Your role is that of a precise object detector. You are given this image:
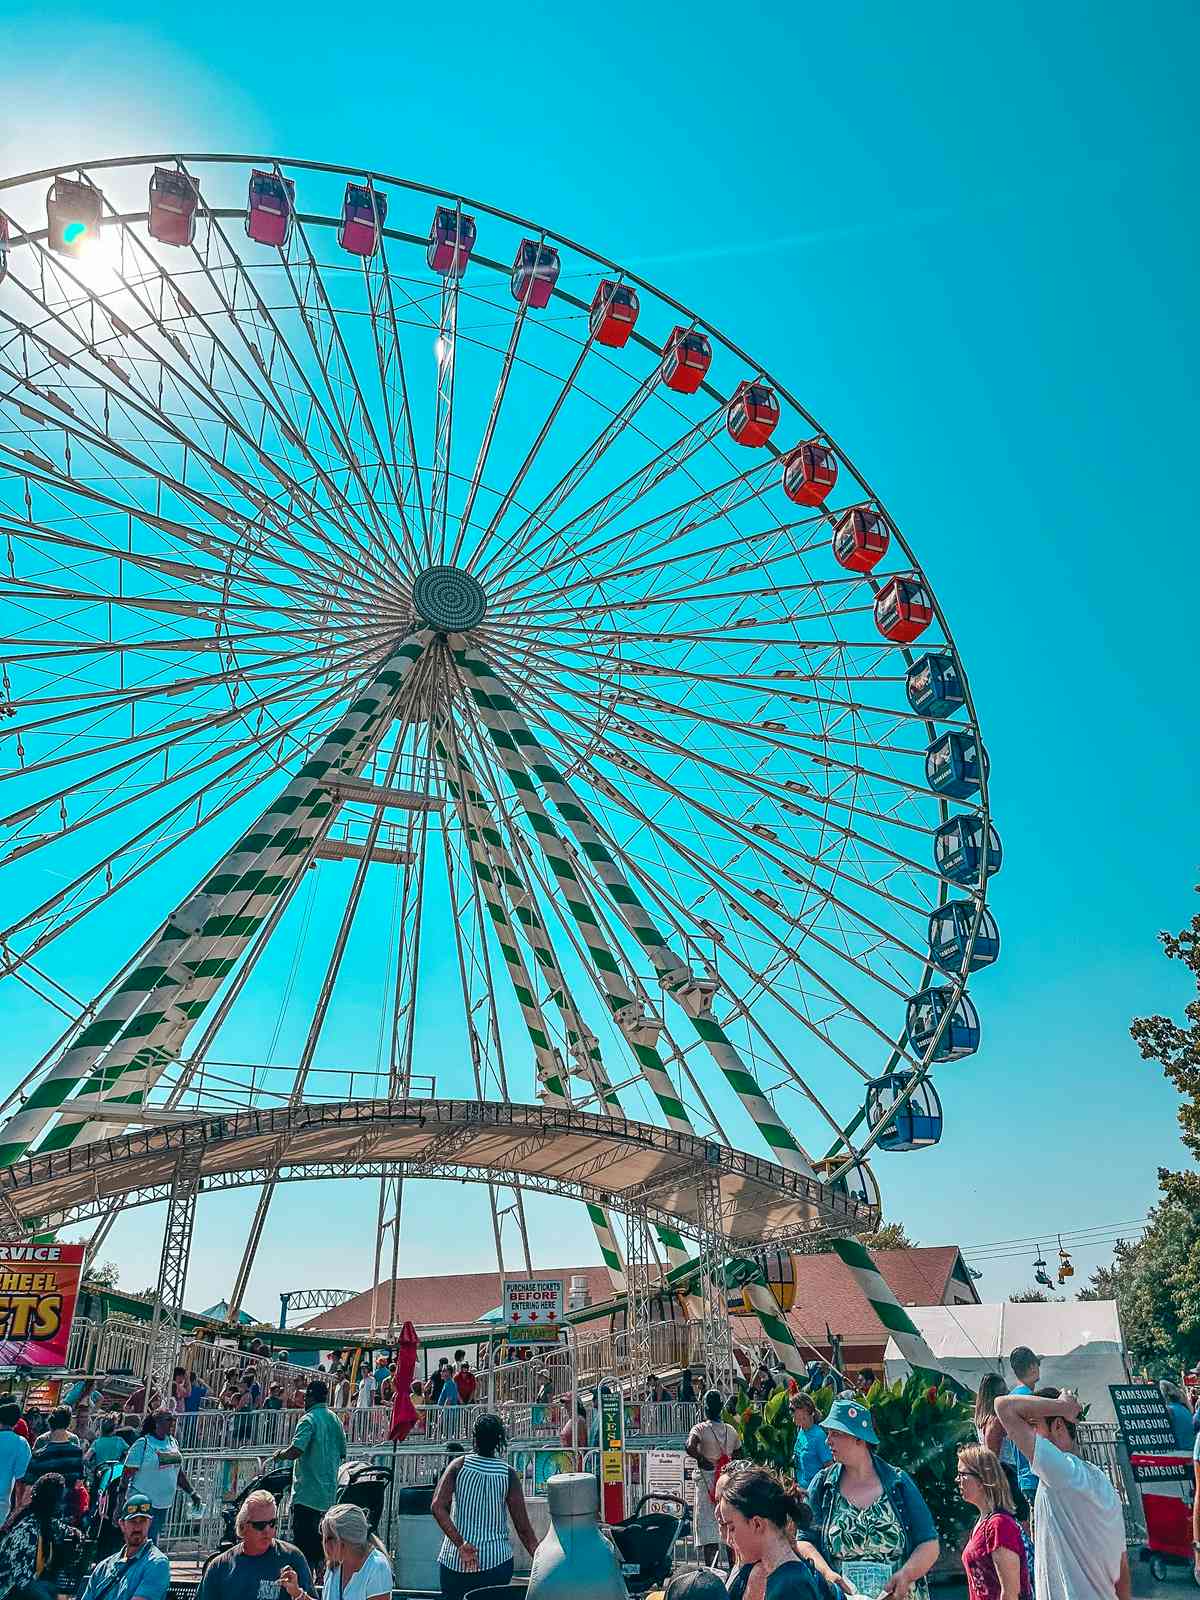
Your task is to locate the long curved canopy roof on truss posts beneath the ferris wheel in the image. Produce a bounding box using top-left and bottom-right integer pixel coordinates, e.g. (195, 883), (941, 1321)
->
(0, 1099), (877, 1250)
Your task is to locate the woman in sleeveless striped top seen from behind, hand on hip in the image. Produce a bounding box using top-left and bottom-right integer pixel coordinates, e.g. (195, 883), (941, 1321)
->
(434, 1411), (538, 1600)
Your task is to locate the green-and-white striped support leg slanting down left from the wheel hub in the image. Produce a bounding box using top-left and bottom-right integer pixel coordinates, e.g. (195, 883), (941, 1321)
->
(0, 630), (432, 1166)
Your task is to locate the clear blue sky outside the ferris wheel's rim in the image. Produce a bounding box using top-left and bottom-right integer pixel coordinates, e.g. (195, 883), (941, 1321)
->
(0, 0), (1200, 1314)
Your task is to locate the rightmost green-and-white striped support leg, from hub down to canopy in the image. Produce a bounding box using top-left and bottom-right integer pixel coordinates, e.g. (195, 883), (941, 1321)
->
(454, 650), (813, 1178)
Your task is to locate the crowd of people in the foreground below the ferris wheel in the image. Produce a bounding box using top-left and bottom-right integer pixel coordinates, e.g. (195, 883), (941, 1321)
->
(0, 1349), (1131, 1600)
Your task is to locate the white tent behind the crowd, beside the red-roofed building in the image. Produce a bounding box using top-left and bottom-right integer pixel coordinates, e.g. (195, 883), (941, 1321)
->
(885, 1301), (1130, 1422)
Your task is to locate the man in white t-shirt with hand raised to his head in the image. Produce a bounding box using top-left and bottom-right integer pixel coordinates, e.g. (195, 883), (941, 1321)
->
(995, 1389), (1131, 1600)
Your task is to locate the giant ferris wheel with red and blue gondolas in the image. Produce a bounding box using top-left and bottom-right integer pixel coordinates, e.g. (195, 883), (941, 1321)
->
(0, 155), (1000, 1304)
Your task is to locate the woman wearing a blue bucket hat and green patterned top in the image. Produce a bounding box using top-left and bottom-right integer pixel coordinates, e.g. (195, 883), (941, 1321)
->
(808, 1398), (939, 1600)
